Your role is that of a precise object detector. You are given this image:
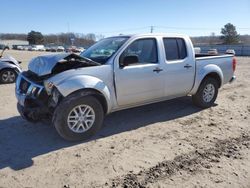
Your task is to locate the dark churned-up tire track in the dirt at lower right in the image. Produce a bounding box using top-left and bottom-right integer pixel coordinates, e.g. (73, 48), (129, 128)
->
(109, 133), (250, 188)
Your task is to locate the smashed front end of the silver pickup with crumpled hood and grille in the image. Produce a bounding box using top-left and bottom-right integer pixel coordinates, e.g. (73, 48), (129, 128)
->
(15, 54), (99, 122)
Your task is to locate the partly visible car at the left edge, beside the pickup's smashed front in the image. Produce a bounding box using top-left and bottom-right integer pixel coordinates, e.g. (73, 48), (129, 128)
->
(0, 48), (21, 84)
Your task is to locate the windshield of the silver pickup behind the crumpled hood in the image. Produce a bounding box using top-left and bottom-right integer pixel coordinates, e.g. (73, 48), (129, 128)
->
(80, 37), (128, 64)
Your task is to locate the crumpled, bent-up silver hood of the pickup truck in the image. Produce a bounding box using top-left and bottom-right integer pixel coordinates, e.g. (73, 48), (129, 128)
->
(28, 53), (89, 76)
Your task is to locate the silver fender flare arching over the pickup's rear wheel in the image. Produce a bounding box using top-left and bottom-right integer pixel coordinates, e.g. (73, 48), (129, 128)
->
(190, 64), (224, 95)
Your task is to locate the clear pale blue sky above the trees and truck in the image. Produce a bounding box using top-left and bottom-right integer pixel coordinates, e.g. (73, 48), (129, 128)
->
(0, 0), (250, 36)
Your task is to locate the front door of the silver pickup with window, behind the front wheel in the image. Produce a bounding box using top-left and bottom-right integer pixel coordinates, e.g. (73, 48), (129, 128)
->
(115, 37), (164, 106)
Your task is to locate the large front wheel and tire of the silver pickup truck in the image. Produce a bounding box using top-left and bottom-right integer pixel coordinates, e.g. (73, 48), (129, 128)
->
(52, 92), (104, 141)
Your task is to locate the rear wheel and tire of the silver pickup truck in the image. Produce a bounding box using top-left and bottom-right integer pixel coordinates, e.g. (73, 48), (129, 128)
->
(192, 78), (219, 108)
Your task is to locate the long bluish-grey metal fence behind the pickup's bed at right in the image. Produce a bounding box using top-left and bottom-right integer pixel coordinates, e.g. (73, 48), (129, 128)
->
(195, 45), (250, 56)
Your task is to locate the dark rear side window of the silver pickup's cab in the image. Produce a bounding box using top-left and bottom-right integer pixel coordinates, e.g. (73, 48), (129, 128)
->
(163, 38), (187, 61)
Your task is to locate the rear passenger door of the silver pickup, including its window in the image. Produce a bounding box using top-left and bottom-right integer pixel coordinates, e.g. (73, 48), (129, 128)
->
(163, 38), (195, 96)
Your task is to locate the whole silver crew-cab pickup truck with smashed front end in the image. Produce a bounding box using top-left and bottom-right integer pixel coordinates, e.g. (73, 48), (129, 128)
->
(16, 34), (236, 141)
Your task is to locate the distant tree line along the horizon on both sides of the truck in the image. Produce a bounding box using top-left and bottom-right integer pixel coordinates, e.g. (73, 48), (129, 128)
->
(0, 23), (250, 47)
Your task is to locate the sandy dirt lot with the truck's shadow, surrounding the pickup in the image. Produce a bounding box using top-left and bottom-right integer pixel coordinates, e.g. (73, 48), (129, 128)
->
(0, 51), (250, 188)
